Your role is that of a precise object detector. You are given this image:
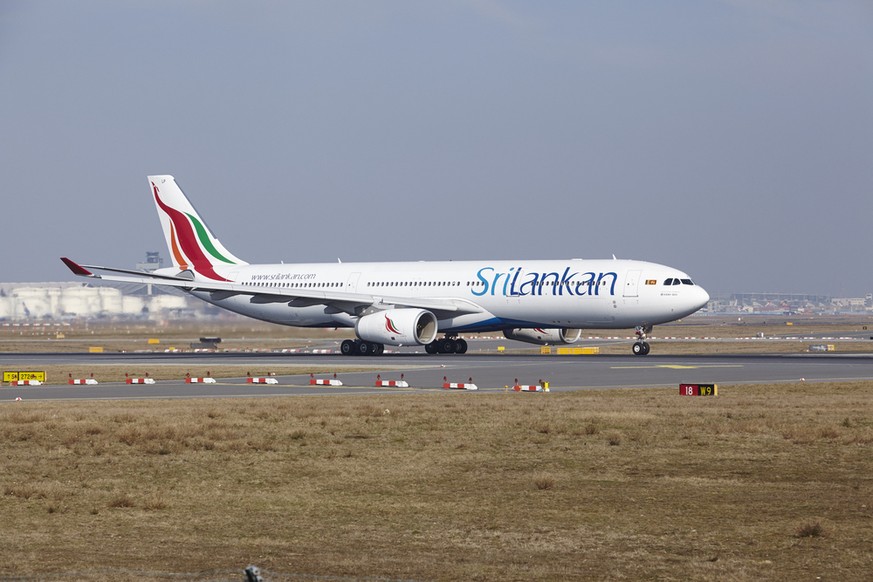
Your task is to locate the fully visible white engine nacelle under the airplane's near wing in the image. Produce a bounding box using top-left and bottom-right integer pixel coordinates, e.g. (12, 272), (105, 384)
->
(355, 309), (438, 346)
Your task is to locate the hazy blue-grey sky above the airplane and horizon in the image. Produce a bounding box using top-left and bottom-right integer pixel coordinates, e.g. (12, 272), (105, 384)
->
(0, 0), (873, 297)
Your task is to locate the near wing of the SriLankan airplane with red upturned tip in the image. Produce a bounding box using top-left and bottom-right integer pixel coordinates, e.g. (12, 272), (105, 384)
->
(61, 257), (483, 315)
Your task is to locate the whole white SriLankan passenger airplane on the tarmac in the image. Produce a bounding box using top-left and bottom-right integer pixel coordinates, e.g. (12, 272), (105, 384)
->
(61, 175), (709, 356)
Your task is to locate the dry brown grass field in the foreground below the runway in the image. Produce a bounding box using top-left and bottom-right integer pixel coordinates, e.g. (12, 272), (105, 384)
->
(0, 382), (873, 580)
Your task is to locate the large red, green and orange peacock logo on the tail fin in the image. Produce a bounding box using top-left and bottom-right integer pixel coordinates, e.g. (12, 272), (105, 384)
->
(152, 183), (236, 281)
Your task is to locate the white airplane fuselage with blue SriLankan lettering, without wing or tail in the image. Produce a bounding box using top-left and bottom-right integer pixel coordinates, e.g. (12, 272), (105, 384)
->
(181, 259), (709, 333)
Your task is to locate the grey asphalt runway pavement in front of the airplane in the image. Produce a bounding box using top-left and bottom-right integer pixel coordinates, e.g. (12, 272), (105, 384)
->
(0, 353), (873, 401)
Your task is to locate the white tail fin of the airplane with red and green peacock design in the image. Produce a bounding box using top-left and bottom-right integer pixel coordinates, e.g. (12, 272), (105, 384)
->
(149, 176), (248, 281)
